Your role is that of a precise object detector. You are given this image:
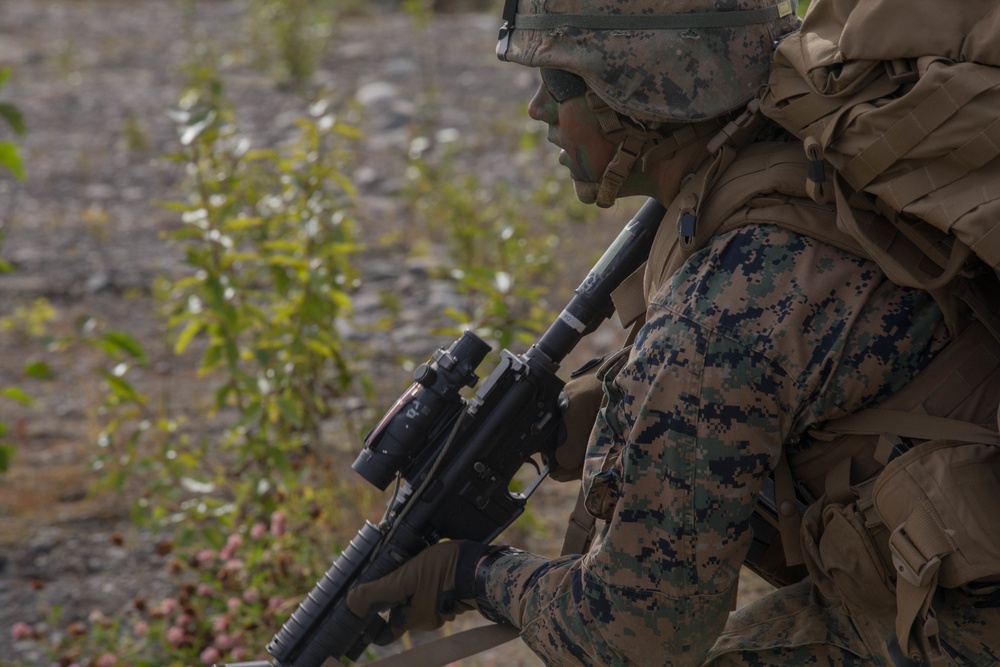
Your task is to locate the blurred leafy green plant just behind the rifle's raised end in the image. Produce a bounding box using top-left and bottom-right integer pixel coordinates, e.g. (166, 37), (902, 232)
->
(404, 128), (594, 349)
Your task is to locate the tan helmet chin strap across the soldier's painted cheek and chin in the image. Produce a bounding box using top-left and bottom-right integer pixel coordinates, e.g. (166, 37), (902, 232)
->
(574, 90), (719, 208)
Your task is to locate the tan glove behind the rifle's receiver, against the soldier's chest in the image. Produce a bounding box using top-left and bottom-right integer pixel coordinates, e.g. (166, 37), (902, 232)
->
(549, 373), (604, 482)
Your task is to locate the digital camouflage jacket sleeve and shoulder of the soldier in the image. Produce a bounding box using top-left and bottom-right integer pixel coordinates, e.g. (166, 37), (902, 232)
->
(480, 225), (948, 666)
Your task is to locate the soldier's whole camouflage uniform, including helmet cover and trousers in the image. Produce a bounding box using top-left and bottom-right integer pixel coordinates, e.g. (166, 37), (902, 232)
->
(487, 0), (1000, 667)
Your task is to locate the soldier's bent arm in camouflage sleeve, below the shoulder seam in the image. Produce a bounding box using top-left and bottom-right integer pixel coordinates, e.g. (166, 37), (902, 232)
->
(488, 311), (787, 665)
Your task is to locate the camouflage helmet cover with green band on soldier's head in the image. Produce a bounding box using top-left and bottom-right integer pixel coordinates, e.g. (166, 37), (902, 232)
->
(497, 0), (799, 121)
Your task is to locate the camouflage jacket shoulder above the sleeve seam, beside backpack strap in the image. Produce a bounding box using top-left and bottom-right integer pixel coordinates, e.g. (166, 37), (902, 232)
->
(647, 225), (886, 381)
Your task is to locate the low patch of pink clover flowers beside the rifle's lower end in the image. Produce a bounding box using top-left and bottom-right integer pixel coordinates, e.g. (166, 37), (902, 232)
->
(19, 484), (372, 667)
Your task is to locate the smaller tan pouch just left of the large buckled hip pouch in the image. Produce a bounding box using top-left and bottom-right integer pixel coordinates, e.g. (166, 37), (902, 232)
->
(802, 481), (896, 615)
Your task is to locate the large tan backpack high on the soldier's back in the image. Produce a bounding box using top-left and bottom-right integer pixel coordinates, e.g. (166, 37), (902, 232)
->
(761, 0), (1000, 335)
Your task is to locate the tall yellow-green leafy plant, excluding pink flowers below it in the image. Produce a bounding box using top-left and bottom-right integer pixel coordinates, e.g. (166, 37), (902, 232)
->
(91, 77), (366, 531)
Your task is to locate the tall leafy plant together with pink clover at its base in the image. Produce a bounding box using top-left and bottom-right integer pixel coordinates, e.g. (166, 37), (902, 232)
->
(12, 70), (376, 667)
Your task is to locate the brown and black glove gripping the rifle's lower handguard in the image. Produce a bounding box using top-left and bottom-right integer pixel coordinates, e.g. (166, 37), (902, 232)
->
(347, 540), (490, 646)
